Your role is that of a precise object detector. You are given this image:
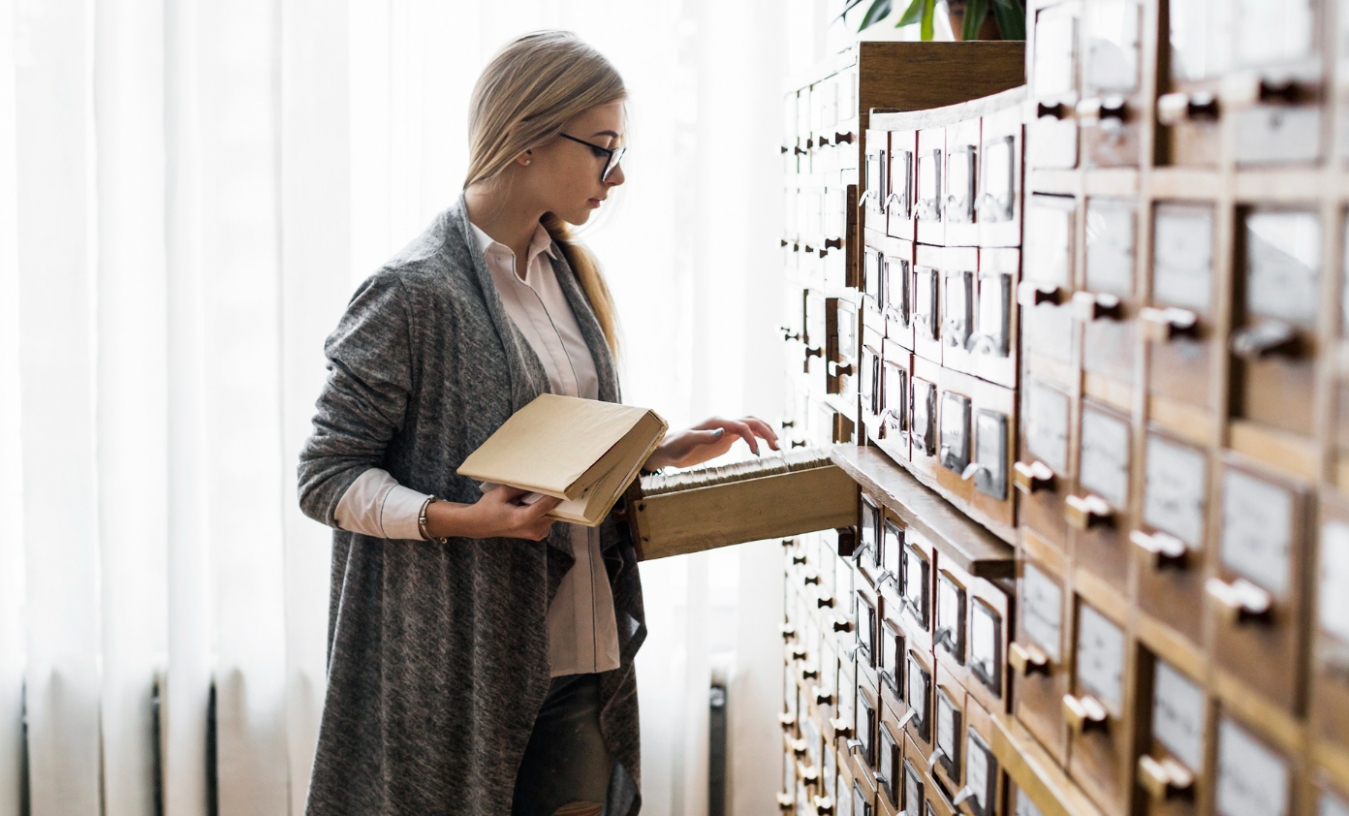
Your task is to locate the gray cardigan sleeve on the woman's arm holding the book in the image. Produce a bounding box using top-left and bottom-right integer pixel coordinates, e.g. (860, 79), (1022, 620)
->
(298, 270), (413, 527)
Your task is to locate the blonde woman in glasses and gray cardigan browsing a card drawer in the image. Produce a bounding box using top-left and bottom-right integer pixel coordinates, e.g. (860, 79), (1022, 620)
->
(299, 32), (777, 816)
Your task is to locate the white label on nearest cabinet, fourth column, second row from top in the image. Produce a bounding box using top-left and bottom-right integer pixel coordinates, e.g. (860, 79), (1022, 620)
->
(1245, 212), (1321, 325)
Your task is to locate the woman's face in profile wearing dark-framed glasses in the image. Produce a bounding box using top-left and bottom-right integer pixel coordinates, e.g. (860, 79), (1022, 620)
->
(521, 103), (623, 224)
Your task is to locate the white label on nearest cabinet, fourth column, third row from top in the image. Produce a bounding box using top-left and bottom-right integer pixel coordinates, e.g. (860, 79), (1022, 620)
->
(1221, 469), (1294, 598)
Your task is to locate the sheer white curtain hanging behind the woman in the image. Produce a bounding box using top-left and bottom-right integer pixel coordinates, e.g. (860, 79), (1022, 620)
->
(0, 0), (814, 816)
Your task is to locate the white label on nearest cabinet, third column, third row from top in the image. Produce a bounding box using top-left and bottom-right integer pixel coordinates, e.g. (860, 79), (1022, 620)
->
(1143, 436), (1209, 549)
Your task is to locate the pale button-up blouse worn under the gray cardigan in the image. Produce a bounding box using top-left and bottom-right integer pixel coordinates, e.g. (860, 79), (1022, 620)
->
(336, 218), (619, 677)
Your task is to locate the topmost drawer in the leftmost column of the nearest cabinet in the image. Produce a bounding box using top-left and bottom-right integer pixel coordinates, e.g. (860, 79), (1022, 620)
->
(1025, 1), (1082, 170)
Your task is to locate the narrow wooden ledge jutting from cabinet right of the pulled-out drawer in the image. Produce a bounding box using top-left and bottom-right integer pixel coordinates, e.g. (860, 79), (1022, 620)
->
(830, 445), (1016, 579)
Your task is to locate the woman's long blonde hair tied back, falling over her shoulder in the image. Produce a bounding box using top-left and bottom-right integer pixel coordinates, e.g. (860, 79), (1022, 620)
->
(464, 31), (627, 355)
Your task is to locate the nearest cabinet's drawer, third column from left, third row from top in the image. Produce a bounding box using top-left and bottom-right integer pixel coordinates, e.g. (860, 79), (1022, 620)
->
(1130, 430), (1210, 649)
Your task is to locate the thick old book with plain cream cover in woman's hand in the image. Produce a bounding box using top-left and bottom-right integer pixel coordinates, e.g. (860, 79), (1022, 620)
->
(459, 394), (669, 527)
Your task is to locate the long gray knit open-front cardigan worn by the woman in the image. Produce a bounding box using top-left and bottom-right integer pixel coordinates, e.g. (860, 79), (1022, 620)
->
(299, 197), (646, 816)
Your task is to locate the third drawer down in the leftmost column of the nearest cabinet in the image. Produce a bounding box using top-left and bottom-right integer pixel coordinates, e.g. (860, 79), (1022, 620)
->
(1012, 378), (1077, 550)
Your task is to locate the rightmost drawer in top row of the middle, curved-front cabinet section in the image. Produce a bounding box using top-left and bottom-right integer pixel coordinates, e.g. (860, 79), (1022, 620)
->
(978, 101), (1021, 247)
